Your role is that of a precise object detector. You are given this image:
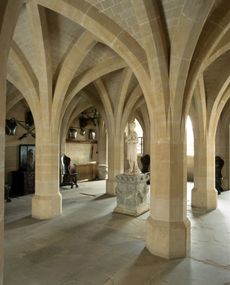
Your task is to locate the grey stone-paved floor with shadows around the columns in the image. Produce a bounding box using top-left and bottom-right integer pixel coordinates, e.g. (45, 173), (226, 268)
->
(4, 181), (230, 285)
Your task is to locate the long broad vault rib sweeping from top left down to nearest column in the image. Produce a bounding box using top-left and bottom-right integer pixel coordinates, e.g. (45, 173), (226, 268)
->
(37, 0), (150, 110)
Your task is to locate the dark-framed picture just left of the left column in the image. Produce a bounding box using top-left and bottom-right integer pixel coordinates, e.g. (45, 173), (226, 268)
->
(19, 144), (35, 171)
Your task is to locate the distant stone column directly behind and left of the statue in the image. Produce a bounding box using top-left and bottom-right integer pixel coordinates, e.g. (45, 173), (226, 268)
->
(106, 134), (124, 196)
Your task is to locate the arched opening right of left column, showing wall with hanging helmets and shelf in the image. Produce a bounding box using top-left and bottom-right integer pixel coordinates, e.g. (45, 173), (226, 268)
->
(61, 106), (101, 183)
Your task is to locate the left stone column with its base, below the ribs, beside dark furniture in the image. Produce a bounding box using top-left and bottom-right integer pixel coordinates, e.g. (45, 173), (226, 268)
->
(32, 138), (62, 219)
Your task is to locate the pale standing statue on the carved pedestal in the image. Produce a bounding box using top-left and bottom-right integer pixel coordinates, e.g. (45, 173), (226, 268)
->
(126, 121), (140, 174)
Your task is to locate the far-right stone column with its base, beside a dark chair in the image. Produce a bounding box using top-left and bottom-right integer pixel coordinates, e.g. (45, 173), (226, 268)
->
(192, 138), (217, 211)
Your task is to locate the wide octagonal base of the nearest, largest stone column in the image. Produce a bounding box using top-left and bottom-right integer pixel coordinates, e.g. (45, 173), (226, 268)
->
(146, 217), (190, 259)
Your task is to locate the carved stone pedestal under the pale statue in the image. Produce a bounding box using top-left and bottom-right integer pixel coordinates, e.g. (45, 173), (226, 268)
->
(114, 173), (149, 216)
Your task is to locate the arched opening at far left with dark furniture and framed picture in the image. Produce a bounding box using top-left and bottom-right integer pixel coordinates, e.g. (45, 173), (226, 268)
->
(5, 96), (35, 201)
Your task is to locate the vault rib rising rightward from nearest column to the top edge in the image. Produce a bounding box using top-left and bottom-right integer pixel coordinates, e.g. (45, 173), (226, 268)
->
(170, 0), (215, 123)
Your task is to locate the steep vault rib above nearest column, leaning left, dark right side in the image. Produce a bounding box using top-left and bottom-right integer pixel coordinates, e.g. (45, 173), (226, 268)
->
(132, 0), (170, 115)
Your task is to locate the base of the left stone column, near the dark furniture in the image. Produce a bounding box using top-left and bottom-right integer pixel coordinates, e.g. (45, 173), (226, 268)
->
(32, 193), (62, 220)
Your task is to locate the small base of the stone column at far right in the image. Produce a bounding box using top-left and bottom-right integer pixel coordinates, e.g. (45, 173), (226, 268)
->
(192, 188), (217, 211)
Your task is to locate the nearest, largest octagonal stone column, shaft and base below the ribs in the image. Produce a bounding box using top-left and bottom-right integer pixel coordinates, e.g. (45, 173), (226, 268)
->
(146, 130), (190, 259)
